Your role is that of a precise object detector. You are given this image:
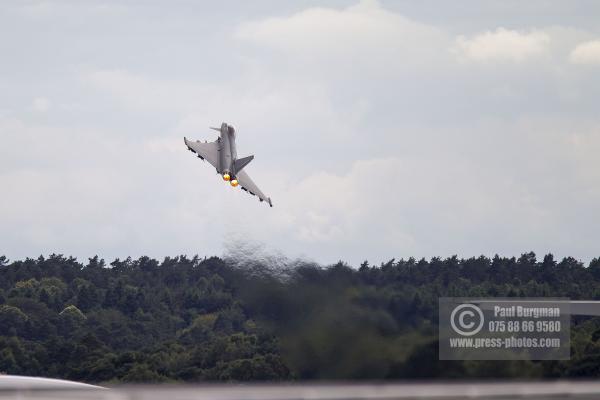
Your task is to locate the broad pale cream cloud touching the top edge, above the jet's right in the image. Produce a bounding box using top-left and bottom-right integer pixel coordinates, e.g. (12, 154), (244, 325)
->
(235, 0), (447, 73)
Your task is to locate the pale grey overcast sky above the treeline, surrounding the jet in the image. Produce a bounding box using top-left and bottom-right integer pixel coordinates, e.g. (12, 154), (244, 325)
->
(0, 0), (600, 265)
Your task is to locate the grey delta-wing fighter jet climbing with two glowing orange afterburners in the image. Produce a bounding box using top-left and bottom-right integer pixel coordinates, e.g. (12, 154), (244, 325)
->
(183, 122), (273, 207)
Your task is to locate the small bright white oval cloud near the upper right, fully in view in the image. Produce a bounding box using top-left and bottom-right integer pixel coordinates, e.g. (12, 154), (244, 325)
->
(452, 28), (550, 63)
